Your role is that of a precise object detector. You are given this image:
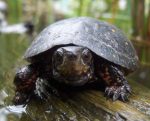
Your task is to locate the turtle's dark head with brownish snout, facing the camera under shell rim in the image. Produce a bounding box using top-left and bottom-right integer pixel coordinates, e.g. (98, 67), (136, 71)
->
(52, 46), (94, 85)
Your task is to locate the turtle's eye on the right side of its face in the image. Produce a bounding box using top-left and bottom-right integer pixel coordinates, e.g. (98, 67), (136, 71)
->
(82, 49), (92, 63)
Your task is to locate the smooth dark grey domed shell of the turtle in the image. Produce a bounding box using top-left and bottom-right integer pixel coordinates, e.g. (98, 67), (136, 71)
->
(24, 17), (138, 71)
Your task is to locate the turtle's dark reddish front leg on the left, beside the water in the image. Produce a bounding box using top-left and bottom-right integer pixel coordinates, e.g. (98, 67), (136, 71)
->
(13, 65), (38, 105)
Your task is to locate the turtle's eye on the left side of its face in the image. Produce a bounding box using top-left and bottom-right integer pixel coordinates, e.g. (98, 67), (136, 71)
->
(54, 51), (63, 65)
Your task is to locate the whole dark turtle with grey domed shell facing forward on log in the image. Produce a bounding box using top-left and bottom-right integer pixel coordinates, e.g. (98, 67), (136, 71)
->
(14, 17), (139, 104)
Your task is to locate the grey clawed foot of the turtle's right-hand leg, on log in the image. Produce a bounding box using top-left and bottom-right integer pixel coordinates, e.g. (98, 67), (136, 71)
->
(105, 85), (131, 102)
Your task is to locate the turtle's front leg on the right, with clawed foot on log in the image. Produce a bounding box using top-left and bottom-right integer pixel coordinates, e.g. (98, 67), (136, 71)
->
(100, 65), (131, 101)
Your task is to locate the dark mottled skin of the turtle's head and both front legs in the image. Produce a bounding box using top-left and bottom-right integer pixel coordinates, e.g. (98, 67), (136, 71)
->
(14, 46), (131, 105)
